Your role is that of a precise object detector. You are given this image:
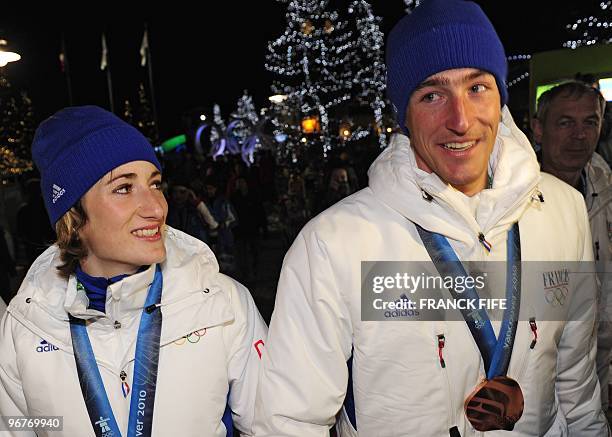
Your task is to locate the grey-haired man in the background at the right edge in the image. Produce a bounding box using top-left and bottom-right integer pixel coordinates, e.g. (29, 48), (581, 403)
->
(533, 81), (612, 411)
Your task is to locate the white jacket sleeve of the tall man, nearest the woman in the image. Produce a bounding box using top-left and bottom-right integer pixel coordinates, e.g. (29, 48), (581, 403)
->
(255, 232), (352, 437)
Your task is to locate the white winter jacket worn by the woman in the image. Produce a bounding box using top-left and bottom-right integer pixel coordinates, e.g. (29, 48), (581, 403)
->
(0, 227), (266, 437)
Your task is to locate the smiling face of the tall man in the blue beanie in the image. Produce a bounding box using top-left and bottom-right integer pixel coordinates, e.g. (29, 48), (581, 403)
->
(406, 68), (501, 196)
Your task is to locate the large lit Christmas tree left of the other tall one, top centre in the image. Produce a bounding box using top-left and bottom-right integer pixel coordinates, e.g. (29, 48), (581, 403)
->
(265, 0), (354, 156)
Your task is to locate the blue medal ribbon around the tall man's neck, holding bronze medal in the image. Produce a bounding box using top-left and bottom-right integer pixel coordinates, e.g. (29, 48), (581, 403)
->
(415, 223), (521, 379)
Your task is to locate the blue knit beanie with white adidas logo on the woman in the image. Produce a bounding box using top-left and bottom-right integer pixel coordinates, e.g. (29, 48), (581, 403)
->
(32, 106), (161, 226)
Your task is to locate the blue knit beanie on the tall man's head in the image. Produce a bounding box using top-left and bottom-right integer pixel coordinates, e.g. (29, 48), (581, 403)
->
(386, 0), (508, 133)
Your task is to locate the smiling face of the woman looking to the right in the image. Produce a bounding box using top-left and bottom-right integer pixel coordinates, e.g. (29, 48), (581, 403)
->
(79, 161), (168, 278)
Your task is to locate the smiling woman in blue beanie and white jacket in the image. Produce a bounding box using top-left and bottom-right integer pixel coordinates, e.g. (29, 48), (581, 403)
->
(0, 106), (266, 437)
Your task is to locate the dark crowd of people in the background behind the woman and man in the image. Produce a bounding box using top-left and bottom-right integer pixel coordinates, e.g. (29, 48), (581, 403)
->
(0, 141), (365, 302)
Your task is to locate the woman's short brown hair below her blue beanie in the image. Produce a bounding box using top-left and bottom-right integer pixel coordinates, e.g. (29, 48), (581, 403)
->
(55, 200), (87, 278)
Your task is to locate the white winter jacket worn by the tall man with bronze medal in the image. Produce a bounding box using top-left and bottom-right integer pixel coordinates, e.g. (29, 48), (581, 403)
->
(255, 108), (607, 437)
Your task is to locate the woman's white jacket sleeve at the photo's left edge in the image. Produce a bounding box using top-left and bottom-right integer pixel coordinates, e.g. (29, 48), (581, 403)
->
(0, 312), (36, 437)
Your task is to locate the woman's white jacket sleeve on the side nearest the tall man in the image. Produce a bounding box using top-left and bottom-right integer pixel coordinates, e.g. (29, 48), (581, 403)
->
(224, 280), (268, 436)
